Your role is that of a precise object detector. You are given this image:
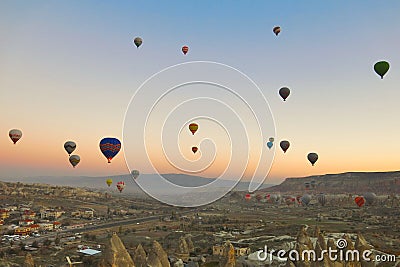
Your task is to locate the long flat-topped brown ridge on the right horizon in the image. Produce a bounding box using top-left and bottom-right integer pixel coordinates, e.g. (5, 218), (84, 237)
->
(261, 171), (400, 194)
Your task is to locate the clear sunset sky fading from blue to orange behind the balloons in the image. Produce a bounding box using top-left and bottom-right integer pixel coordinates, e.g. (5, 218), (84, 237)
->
(0, 0), (400, 183)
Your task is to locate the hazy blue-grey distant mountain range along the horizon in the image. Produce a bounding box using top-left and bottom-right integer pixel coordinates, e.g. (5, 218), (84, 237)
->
(2, 174), (273, 194)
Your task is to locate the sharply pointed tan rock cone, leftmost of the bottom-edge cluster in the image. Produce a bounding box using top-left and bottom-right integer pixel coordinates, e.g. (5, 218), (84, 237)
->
(100, 233), (135, 267)
